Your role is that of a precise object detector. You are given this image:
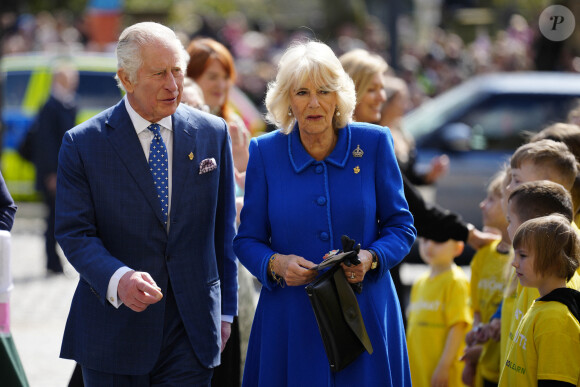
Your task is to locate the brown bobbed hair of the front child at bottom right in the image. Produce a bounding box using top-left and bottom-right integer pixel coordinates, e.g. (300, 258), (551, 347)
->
(513, 214), (580, 281)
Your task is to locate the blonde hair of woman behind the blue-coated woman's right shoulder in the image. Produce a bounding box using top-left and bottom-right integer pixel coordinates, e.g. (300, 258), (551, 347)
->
(339, 48), (389, 107)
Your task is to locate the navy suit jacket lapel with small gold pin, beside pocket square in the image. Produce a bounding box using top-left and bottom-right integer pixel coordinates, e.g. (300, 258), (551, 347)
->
(171, 108), (199, 218)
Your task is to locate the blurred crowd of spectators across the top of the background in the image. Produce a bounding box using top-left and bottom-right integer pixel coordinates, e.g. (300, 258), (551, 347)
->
(0, 11), (580, 115)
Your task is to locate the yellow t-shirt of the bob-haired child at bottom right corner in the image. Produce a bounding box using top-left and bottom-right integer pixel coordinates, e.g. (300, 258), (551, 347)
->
(499, 301), (580, 387)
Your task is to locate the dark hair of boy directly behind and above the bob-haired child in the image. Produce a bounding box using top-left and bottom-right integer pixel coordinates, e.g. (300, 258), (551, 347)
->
(508, 180), (574, 222)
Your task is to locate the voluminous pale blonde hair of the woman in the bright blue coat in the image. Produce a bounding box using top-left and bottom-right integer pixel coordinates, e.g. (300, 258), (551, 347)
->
(265, 41), (356, 134)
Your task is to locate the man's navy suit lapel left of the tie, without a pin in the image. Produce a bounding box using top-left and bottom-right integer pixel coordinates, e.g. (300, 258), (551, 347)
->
(107, 100), (168, 224)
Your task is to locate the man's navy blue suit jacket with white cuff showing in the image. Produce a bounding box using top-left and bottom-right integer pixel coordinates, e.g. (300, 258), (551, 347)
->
(56, 100), (237, 375)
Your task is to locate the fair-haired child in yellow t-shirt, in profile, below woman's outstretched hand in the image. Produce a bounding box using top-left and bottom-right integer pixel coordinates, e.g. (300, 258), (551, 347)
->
(462, 170), (512, 387)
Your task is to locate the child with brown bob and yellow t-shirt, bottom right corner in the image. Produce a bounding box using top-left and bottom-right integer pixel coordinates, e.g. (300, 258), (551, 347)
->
(499, 215), (580, 387)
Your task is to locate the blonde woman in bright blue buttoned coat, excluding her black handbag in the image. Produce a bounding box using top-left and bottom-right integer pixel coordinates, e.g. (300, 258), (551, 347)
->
(234, 42), (416, 387)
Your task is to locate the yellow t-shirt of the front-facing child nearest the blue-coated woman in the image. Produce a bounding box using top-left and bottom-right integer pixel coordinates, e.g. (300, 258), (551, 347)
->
(407, 264), (472, 387)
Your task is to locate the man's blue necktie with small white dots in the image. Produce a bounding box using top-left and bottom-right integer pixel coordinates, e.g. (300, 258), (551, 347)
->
(147, 124), (169, 225)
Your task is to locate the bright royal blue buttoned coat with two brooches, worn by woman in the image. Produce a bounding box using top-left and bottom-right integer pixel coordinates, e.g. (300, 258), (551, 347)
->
(234, 123), (416, 387)
